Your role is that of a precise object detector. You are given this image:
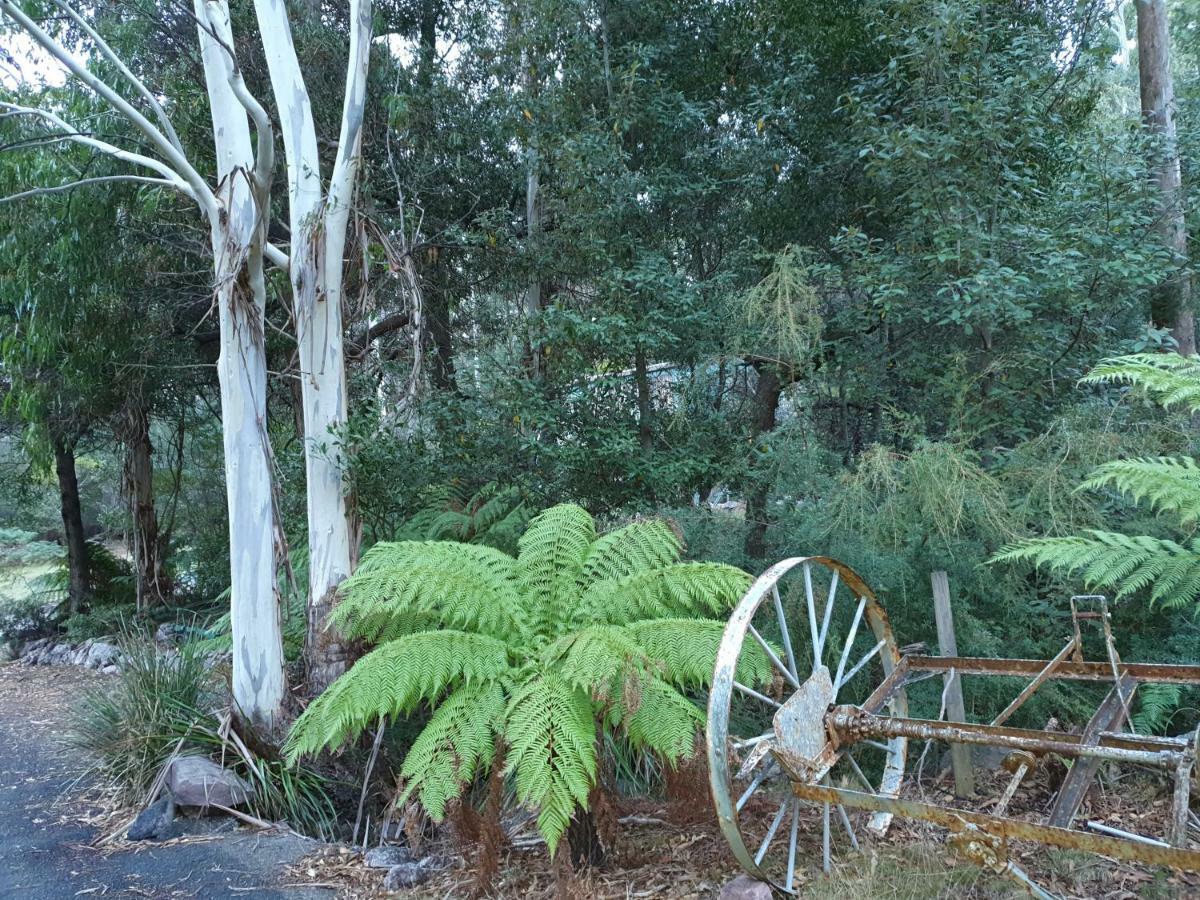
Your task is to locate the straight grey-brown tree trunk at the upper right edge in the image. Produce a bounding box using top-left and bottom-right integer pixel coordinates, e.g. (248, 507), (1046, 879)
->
(1135, 0), (1196, 355)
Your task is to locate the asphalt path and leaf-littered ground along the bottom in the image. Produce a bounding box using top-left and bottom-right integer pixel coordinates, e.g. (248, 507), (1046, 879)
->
(0, 664), (1200, 900)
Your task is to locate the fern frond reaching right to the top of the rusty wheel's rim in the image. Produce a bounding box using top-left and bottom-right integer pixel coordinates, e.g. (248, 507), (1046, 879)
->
(581, 563), (751, 624)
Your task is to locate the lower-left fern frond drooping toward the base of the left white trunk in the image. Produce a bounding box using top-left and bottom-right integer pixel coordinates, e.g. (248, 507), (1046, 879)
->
(286, 631), (510, 762)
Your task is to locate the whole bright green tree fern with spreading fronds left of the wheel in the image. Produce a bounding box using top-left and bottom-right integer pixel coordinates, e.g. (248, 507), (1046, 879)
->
(287, 504), (748, 852)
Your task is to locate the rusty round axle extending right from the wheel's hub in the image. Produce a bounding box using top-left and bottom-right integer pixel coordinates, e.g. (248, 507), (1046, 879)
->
(826, 707), (1184, 769)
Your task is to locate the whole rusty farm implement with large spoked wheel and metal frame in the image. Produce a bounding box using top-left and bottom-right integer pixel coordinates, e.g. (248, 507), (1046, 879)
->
(708, 557), (1200, 896)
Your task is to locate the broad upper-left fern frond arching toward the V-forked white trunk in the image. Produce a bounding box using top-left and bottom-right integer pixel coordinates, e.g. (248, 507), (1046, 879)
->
(331, 541), (524, 641)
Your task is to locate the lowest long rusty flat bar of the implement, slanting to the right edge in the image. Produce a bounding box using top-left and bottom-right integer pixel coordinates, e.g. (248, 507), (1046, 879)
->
(792, 782), (1200, 871)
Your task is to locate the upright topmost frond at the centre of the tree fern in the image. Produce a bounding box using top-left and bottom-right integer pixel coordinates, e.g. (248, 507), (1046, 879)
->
(517, 503), (596, 635)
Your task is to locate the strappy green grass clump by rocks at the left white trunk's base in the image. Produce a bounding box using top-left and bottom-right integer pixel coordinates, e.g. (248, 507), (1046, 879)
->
(68, 634), (337, 839)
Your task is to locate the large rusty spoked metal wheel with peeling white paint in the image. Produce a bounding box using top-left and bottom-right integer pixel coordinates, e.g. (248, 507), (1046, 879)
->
(708, 557), (907, 893)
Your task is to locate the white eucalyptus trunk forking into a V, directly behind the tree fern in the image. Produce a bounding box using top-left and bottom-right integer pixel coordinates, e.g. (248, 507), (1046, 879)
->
(254, 0), (371, 692)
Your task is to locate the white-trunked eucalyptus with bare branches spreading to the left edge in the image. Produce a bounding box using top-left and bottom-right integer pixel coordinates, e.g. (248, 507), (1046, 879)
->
(0, 0), (287, 730)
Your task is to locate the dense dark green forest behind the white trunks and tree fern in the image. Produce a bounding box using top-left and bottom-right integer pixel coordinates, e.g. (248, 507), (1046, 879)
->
(0, 0), (1200, 873)
